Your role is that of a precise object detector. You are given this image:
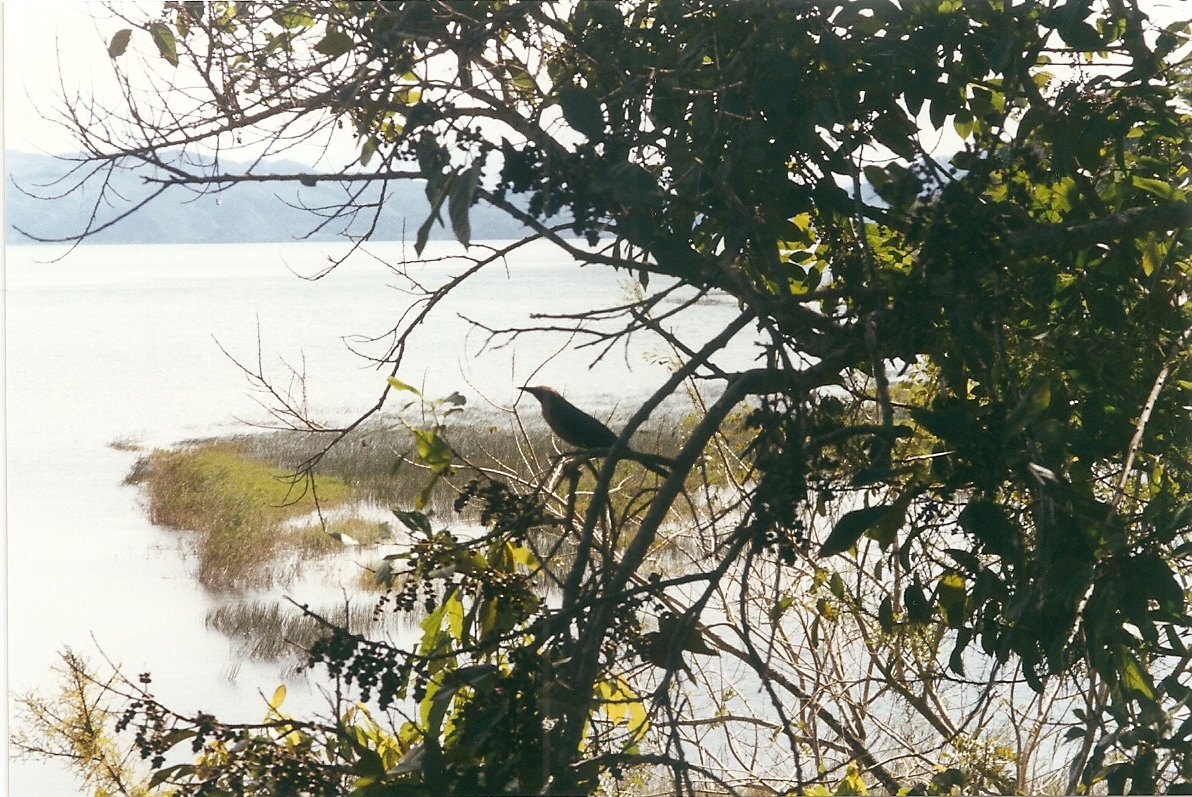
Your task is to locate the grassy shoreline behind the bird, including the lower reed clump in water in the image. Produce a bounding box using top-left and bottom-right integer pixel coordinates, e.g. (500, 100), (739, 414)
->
(123, 412), (734, 677)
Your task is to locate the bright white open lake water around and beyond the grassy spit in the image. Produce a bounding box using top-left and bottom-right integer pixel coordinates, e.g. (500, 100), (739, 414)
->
(6, 235), (751, 796)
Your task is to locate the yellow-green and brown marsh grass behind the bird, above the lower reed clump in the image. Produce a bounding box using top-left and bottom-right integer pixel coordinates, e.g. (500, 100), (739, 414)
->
(128, 400), (743, 591)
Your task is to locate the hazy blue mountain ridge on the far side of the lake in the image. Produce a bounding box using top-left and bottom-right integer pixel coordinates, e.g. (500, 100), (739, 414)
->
(5, 150), (536, 244)
